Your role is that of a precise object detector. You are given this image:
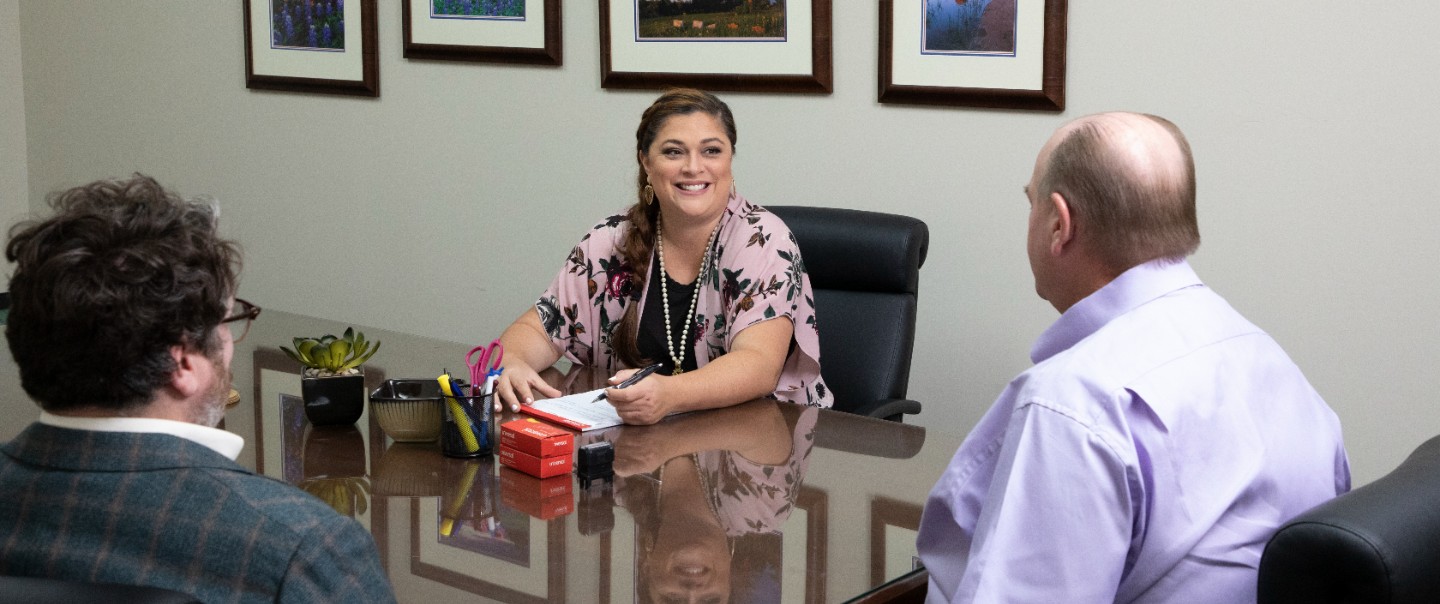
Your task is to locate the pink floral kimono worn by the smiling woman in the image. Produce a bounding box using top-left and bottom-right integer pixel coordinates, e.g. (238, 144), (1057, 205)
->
(536, 195), (832, 407)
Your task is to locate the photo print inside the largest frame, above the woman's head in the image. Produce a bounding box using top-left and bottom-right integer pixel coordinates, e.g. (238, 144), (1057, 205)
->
(635, 0), (786, 40)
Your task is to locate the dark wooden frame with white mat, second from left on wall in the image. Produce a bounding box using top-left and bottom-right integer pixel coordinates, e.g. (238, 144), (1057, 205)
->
(400, 0), (563, 65)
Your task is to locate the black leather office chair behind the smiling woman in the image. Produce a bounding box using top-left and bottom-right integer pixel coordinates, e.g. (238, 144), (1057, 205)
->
(766, 206), (930, 421)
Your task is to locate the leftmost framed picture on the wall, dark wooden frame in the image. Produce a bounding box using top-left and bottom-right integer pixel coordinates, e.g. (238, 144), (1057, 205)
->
(242, 0), (380, 97)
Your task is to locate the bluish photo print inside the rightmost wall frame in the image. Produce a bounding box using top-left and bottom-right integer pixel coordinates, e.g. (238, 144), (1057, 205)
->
(922, 0), (1017, 55)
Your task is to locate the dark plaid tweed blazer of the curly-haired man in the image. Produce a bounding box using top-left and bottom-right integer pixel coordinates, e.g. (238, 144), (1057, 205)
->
(0, 424), (395, 603)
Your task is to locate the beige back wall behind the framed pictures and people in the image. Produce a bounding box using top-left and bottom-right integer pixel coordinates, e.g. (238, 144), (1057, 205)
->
(8, 0), (1440, 481)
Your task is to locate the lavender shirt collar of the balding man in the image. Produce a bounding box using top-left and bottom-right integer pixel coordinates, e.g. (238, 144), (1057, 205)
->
(1030, 258), (1204, 363)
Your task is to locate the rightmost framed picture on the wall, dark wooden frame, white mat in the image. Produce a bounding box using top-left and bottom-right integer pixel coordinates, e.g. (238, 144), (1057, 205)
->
(880, 0), (1067, 111)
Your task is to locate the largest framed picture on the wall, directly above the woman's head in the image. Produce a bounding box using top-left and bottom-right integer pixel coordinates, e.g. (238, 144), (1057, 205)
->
(600, 0), (834, 94)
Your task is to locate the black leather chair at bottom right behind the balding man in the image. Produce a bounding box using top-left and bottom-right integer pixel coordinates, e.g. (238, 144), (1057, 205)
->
(1257, 437), (1440, 604)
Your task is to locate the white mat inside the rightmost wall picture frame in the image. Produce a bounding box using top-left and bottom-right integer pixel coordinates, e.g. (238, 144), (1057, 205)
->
(890, 0), (1045, 91)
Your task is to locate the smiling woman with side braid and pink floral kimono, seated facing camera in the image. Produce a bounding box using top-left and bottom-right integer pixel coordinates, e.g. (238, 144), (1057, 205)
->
(497, 88), (831, 424)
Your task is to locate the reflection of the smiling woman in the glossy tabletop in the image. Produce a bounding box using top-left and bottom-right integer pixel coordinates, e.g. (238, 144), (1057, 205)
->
(604, 401), (818, 603)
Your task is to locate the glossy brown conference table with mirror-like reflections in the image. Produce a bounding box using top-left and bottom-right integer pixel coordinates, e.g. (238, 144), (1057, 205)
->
(213, 310), (962, 603)
